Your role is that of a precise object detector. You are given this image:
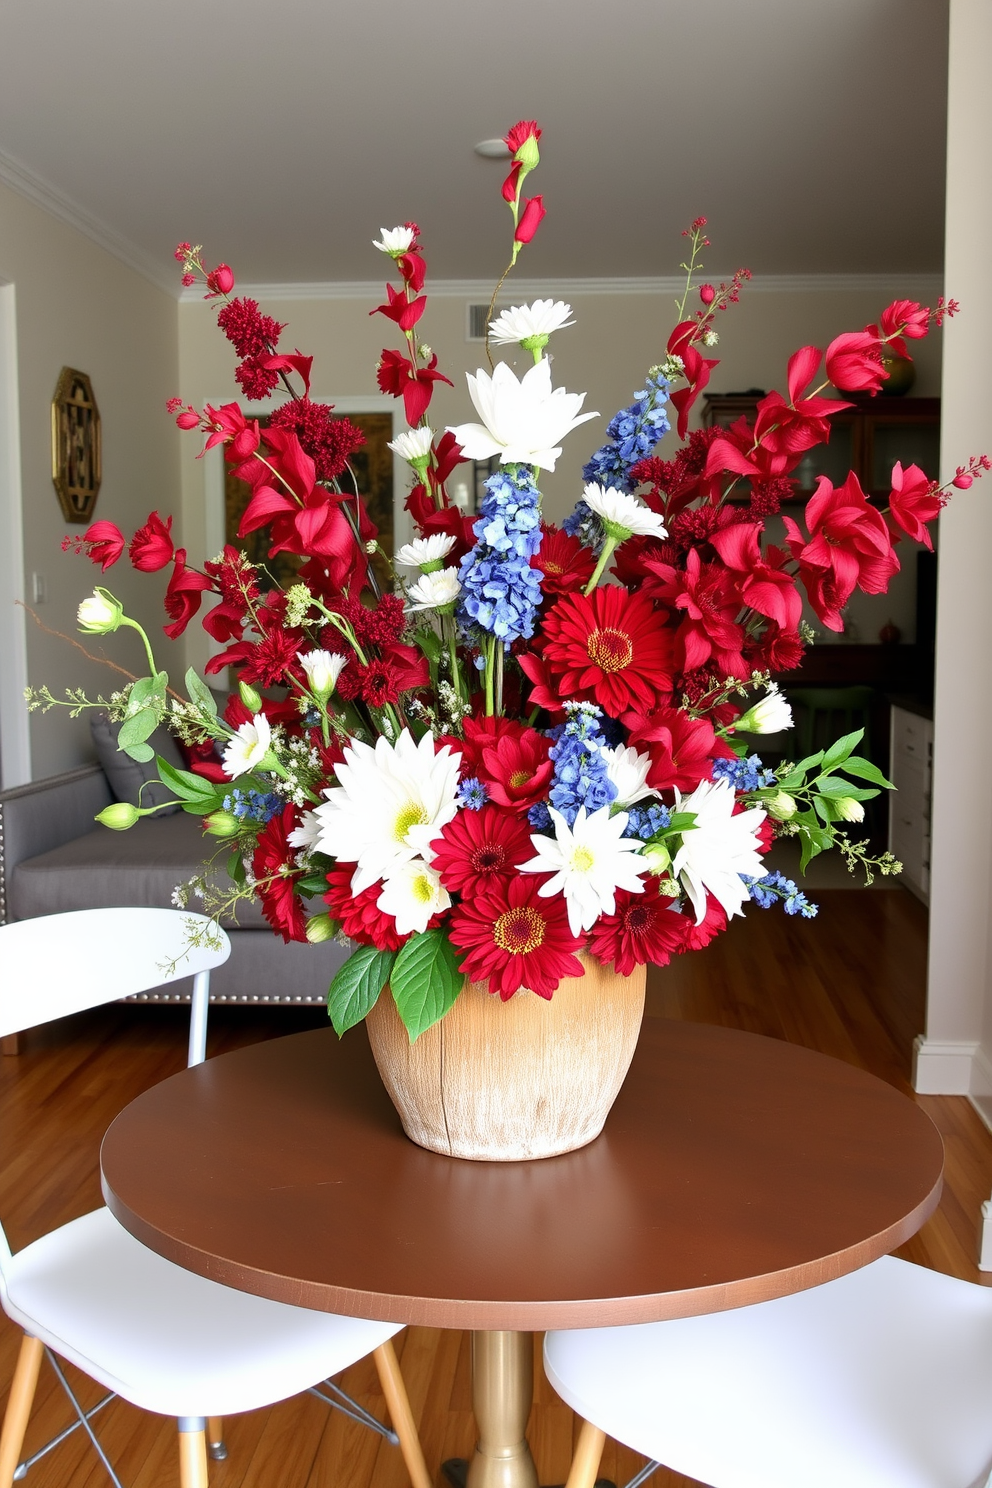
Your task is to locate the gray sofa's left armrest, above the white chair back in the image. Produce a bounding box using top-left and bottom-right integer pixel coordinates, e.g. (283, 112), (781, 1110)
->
(0, 765), (113, 924)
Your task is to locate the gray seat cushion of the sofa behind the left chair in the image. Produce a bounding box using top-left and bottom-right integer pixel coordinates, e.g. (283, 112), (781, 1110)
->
(7, 811), (268, 929)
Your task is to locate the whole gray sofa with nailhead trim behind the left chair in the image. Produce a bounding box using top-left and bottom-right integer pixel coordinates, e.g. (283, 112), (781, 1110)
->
(0, 765), (348, 1004)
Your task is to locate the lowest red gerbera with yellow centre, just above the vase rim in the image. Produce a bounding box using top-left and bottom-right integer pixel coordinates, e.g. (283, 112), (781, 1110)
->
(448, 873), (584, 1003)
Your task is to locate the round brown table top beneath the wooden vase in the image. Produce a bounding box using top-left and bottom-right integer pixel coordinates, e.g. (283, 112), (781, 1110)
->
(101, 1018), (943, 1330)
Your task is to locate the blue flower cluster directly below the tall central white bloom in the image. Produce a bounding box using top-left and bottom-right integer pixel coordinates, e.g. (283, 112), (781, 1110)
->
(457, 466), (544, 650)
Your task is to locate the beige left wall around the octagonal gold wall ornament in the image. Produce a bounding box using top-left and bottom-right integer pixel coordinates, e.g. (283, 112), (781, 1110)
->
(0, 186), (180, 778)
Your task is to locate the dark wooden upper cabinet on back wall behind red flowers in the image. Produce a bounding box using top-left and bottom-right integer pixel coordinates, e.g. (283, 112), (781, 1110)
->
(703, 393), (940, 500)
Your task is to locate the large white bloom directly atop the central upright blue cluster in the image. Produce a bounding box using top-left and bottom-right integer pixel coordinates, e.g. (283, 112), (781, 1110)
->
(448, 357), (599, 470)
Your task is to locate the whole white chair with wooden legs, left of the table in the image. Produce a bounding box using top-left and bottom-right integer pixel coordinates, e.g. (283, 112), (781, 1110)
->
(0, 909), (431, 1488)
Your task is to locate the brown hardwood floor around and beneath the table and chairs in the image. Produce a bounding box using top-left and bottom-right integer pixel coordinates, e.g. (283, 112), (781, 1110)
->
(0, 888), (992, 1488)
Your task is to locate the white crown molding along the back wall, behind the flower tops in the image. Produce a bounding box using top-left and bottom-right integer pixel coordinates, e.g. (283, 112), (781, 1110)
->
(180, 274), (943, 305)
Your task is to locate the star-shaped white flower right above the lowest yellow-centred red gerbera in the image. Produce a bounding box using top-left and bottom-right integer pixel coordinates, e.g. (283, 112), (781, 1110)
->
(521, 806), (648, 934)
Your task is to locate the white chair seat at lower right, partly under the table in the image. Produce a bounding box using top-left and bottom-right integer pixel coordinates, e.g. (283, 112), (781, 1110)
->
(544, 1256), (992, 1488)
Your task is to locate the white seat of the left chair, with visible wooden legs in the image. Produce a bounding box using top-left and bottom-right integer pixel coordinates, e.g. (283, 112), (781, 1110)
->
(4, 1208), (400, 1417)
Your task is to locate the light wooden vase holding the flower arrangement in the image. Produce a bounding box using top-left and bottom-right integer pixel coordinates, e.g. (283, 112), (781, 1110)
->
(366, 955), (645, 1162)
